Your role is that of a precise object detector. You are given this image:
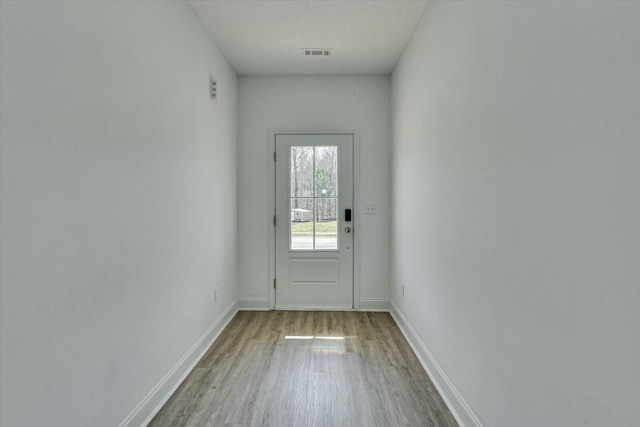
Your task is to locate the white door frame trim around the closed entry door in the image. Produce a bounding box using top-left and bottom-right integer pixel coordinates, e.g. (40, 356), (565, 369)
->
(267, 129), (362, 311)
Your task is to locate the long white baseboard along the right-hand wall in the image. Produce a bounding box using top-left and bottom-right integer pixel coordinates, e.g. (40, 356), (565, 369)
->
(391, 301), (482, 427)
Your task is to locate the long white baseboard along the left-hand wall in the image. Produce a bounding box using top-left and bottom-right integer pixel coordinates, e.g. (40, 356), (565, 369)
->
(119, 300), (238, 427)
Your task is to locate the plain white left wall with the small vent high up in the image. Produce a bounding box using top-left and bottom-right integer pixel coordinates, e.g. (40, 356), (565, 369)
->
(0, 1), (237, 427)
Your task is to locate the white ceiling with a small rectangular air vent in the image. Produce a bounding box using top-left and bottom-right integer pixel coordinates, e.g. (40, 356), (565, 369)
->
(189, 0), (428, 75)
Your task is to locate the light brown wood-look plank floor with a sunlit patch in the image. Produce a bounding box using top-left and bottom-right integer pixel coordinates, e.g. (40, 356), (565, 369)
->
(150, 311), (457, 427)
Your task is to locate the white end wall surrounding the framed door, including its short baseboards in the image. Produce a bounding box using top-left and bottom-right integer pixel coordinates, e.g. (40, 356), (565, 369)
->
(238, 76), (390, 308)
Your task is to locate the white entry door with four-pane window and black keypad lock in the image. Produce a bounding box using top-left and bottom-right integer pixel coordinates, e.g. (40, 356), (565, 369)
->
(275, 134), (354, 310)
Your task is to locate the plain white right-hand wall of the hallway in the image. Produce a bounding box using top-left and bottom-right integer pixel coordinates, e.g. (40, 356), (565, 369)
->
(392, 1), (640, 426)
